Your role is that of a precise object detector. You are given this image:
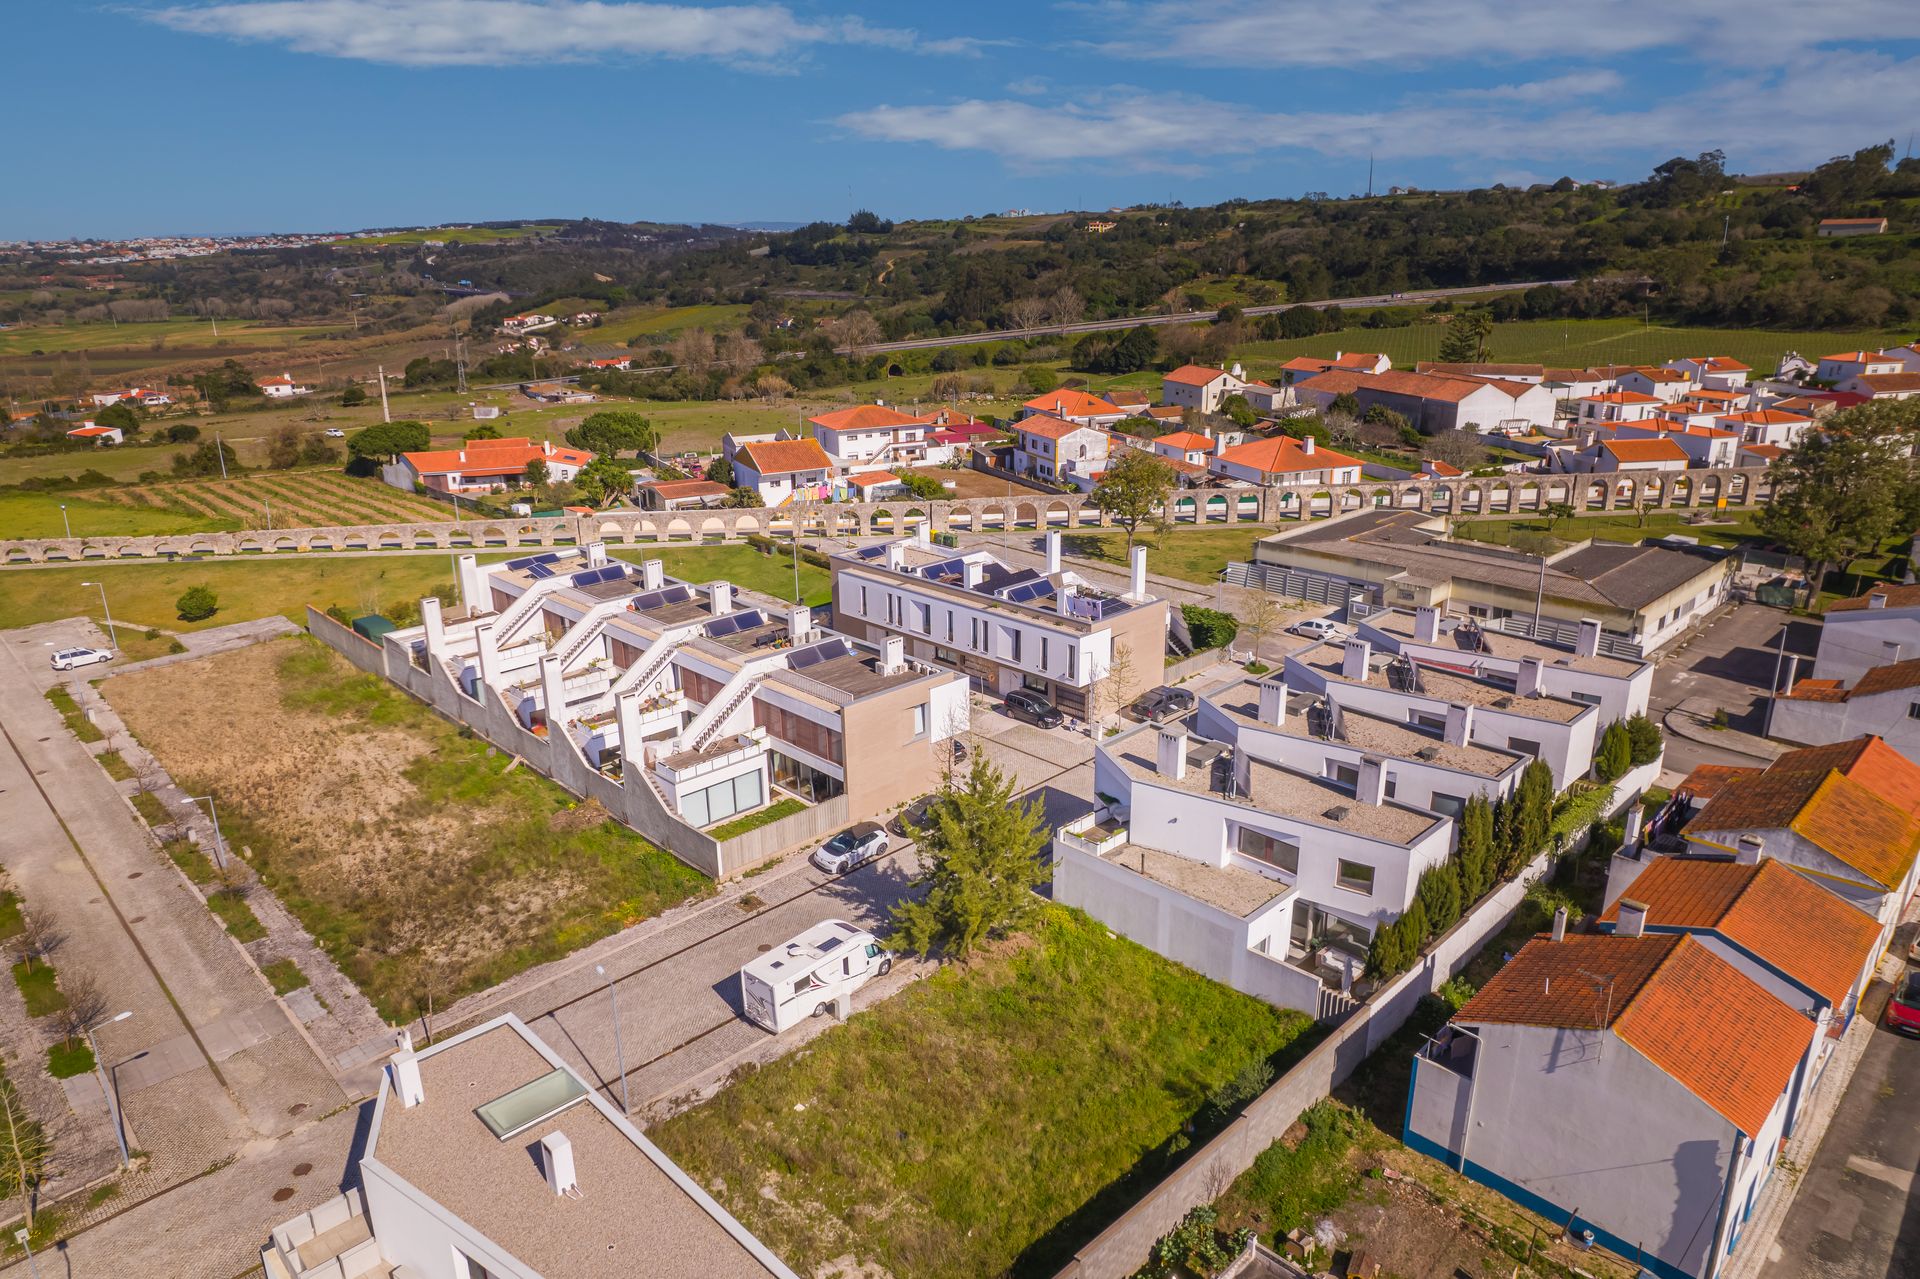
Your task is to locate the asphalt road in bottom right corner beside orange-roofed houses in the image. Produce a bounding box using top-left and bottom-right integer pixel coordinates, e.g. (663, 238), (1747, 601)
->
(1761, 967), (1920, 1279)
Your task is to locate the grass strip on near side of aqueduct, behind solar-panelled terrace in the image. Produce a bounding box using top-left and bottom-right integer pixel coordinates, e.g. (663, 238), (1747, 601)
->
(0, 545), (829, 632)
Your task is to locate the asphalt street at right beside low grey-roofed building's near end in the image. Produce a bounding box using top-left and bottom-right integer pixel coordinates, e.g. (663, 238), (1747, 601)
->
(1647, 603), (1820, 774)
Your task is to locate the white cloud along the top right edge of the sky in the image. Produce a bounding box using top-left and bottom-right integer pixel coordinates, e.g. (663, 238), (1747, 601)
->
(1098, 0), (1920, 67)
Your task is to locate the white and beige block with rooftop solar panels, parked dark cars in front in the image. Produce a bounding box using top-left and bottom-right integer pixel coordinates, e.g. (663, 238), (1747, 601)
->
(831, 530), (1167, 720)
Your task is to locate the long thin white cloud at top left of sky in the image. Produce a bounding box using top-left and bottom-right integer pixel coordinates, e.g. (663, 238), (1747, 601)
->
(144, 0), (977, 67)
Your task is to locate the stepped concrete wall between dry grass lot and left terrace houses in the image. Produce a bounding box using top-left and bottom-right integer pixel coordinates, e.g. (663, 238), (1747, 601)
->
(307, 607), (847, 880)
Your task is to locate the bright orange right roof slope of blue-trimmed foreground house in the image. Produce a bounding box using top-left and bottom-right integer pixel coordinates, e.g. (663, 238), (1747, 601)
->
(1615, 933), (1814, 1137)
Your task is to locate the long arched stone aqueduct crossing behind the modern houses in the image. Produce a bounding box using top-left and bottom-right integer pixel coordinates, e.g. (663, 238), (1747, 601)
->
(0, 467), (1768, 565)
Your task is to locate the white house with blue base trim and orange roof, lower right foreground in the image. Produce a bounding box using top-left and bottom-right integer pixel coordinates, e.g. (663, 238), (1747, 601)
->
(1405, 916), (1816, 1279)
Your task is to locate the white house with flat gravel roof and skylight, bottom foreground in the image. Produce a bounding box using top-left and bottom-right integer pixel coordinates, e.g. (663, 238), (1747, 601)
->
(261, 1014), (797, 1279)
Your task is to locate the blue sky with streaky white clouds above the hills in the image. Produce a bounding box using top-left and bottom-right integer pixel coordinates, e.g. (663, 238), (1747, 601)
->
(11, 0), (1920, 240)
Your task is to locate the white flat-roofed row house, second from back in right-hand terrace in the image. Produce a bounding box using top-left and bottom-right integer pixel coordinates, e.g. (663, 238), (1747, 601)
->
(1286, 636), (1605, 791)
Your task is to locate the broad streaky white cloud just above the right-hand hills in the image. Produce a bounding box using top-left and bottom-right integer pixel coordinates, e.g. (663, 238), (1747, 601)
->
(835, 50), (1920, 177)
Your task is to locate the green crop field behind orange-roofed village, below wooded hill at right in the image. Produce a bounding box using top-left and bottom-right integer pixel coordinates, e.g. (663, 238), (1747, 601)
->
(1235, 319), (1912, 376)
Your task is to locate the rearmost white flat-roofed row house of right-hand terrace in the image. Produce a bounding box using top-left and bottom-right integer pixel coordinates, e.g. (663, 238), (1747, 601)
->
(1357, 605), (1653, 724)
